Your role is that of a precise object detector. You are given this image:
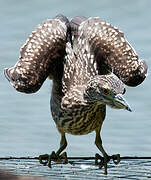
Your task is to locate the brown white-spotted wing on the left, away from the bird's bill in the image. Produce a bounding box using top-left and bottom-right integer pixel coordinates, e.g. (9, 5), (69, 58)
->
(4, 15), (69, 93)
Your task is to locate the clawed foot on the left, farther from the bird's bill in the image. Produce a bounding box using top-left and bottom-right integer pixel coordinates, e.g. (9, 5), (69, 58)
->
(39, 151), (68, 168)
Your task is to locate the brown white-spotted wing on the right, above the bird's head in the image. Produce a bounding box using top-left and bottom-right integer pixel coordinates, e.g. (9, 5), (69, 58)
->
(76, 18), (147, 86)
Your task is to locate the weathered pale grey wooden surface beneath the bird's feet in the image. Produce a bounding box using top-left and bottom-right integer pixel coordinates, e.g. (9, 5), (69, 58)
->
(0, 159), (151, 180)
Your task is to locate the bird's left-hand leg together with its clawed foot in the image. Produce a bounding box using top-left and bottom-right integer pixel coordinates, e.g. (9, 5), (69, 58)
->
(39, 130), (68, 168)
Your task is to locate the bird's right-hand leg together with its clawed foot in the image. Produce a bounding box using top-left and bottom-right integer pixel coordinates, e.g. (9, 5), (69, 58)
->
(95, 127), (120, 175)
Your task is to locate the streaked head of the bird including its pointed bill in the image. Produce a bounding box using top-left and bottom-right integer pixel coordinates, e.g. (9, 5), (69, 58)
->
(84, 73), (131, 111)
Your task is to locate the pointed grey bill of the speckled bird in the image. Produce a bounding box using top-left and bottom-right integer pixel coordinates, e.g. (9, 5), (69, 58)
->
(113, 94), (132, 112)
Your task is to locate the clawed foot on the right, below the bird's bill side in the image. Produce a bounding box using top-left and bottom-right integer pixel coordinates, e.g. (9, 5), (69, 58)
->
(95, 154), (120, 175)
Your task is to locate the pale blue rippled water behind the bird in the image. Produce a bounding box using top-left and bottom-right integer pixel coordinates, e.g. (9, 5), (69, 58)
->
(0, 0), (151, 157)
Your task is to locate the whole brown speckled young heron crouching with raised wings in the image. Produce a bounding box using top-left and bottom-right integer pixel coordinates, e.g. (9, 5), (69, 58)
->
(4, 15), (147, 174)
